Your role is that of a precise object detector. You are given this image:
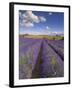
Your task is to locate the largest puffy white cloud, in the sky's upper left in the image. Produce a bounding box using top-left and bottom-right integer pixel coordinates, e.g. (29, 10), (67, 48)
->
(19, 10), (46, 27)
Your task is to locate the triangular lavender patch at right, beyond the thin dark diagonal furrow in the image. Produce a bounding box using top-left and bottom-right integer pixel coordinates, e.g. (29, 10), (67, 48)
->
(45, 40), (64, 61)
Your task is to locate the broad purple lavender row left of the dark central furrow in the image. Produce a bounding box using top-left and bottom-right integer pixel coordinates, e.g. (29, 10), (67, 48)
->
(19, 39), (42, 79)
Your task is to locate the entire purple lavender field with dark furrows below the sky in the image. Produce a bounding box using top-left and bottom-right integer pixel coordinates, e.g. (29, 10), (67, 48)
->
(19, 36), (64, 79)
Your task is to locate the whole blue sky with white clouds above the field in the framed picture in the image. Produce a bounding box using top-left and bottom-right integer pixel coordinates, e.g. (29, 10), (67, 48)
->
(19, 10), (64, 35)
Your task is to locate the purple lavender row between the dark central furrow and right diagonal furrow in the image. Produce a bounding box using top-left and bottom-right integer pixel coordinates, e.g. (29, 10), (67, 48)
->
(41, 40), (64, 78)
